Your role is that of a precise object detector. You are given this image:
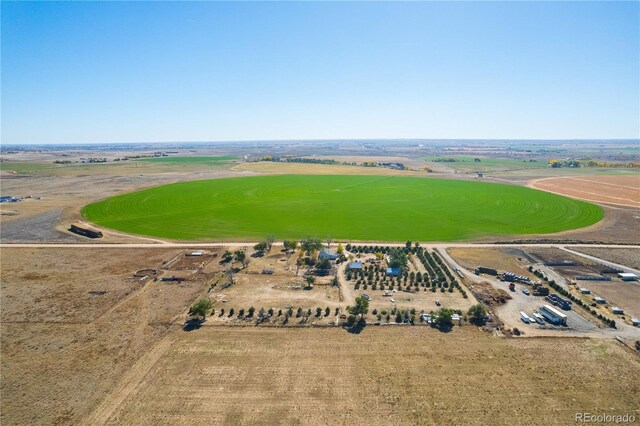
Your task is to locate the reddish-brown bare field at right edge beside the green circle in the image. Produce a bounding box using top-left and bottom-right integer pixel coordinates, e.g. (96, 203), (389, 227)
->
(529, 174), (640, 207)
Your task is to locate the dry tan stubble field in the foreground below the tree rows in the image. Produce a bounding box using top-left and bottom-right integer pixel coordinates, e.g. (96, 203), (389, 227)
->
(109, 327), (640, 425)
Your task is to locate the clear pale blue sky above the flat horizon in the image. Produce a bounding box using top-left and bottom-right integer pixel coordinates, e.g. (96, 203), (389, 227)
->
(1, 1), (640, 144)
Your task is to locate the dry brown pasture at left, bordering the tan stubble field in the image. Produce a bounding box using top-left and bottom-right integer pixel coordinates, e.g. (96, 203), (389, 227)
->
(0, 248), (212, 424)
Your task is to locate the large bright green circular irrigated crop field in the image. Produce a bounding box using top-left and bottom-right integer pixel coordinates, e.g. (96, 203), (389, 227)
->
(82, 175), (604, 241)
